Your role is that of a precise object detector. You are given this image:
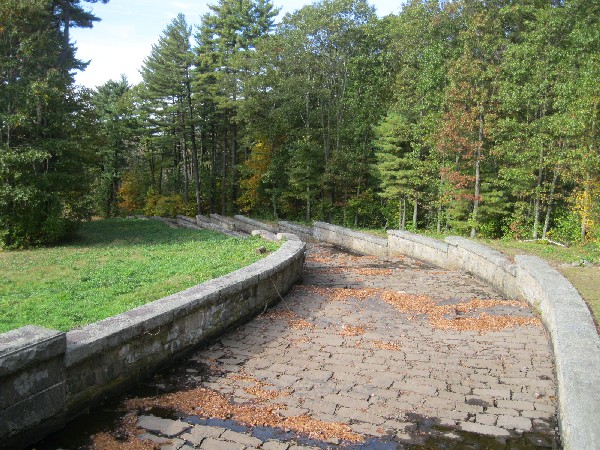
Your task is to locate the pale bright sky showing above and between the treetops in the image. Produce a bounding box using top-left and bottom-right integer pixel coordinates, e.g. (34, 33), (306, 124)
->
(71, 0), (402, 88)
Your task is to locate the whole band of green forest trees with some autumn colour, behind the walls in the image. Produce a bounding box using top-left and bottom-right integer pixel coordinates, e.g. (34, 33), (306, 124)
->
(0, 0), (600, 247)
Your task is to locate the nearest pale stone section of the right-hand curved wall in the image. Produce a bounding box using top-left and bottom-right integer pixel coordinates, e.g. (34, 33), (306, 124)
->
(515, 255), (600, 449)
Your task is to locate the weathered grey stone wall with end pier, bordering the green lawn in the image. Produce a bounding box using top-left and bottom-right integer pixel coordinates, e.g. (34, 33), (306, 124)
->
(0, 240), (305, 448)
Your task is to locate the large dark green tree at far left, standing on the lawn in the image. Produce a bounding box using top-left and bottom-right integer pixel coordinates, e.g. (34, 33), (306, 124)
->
(0, 0), (108, 247)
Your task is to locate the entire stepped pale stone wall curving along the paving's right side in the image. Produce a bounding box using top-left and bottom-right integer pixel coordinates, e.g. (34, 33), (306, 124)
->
(314, 222), (600, 449)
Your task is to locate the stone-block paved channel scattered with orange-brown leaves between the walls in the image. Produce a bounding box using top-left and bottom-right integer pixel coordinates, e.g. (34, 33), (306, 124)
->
(35, 245), (558, 450)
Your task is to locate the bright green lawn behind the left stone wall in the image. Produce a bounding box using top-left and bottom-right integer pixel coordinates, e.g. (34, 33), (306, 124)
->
(0, 219), (278, 332)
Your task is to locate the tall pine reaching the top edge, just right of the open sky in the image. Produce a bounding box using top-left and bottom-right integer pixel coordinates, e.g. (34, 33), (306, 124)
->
(196, 0), (278, 213)
